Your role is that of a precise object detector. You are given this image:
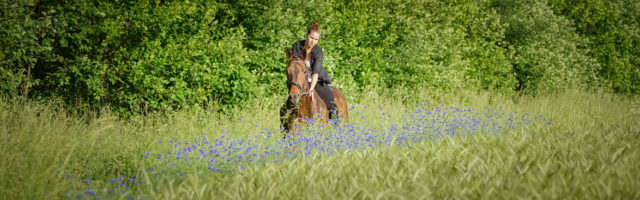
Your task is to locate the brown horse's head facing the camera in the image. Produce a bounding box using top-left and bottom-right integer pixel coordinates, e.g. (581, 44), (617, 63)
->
(287, 50), (309, 103)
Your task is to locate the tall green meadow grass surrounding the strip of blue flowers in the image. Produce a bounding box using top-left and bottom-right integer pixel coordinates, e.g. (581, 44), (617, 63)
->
(0, 91), (640, 199)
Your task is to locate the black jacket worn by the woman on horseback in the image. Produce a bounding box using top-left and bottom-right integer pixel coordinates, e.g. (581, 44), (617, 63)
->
(291, 40), (331, 84)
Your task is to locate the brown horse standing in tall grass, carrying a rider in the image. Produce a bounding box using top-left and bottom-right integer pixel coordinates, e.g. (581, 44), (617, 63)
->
(280, 50), (349, 137)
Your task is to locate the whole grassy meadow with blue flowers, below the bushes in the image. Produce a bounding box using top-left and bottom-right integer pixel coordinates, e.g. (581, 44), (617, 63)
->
(0, 90), (640, 199)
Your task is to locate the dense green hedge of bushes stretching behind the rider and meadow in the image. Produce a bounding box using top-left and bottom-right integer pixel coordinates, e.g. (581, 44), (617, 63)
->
(0, 0), (640, 114)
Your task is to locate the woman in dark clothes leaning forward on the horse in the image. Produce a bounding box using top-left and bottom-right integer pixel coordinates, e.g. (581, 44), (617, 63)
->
(291, 22), (337, 119)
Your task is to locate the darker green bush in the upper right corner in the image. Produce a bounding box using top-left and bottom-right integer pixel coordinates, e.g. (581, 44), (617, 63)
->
(549, 0), (640, 94)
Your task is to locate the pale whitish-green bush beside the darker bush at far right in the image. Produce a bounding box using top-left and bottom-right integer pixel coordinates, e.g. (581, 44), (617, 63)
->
(493, 0), (597, 93)
